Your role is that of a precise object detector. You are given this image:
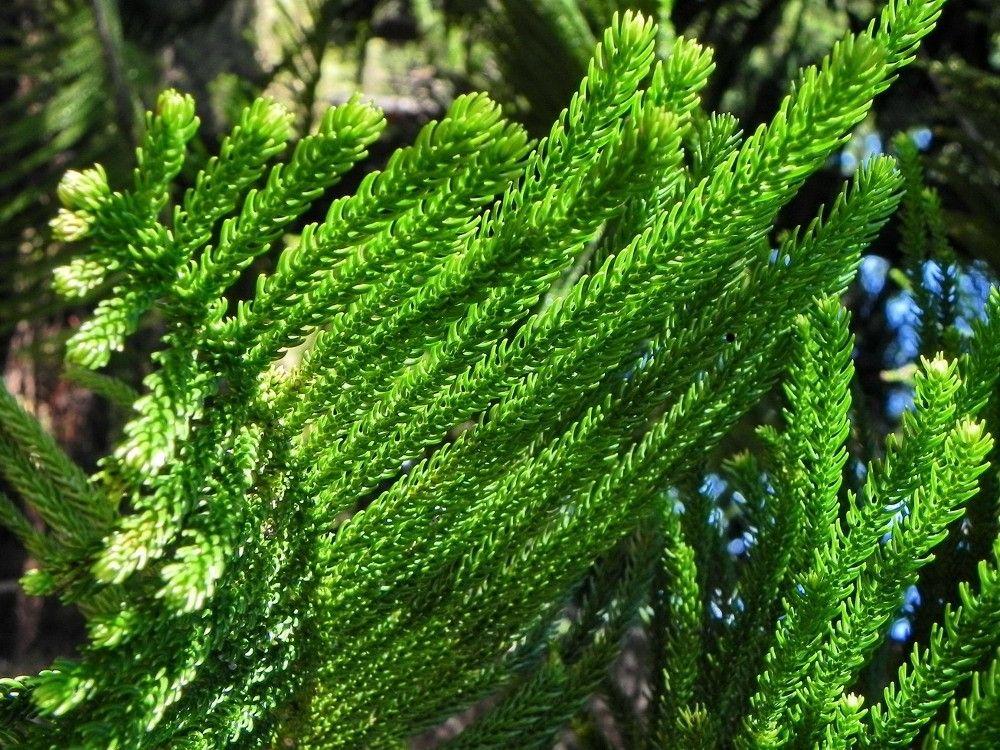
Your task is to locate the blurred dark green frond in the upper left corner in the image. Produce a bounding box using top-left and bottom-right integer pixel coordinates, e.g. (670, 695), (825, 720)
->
(0, 0), (144, 330)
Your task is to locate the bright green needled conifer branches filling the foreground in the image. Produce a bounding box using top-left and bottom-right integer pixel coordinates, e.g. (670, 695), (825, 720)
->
(0, 0), (1000, 748)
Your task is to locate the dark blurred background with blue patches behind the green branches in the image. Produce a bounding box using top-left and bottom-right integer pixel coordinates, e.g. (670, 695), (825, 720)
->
(0, 0), (1000, 748)
